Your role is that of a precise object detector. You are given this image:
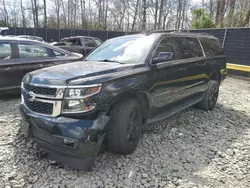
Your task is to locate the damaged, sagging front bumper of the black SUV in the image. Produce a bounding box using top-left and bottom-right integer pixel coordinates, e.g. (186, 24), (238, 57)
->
(20, 105), (109, 170)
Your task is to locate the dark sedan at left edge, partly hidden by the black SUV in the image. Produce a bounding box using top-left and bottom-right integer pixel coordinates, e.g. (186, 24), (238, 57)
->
(0, 37), (83, 94)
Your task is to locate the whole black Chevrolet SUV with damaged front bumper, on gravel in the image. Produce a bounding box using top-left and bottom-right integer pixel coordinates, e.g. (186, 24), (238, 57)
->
(20, 32), (226, 170)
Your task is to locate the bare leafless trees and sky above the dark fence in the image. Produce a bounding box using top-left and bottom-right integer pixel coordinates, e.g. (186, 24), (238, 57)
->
(0, 0), (250, 31)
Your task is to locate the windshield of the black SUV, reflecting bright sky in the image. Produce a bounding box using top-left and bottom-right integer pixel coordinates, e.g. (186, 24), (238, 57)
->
(85, 35), (155, 64)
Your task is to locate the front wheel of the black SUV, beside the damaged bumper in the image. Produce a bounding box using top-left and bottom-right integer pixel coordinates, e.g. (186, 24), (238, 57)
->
(107, 99), (142, 155)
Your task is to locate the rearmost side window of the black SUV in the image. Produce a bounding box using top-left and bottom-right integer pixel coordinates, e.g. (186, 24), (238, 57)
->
(200, 38), (222, 56)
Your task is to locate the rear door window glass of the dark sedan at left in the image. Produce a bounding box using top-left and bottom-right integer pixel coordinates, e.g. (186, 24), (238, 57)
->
(18, 44), (49, 58)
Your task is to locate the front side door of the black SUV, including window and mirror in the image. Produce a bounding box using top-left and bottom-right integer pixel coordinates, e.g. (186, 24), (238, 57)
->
(149, 37), (192, 117)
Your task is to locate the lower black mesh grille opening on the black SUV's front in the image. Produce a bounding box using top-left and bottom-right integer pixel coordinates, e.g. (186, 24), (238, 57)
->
(22, 92), (53, 115)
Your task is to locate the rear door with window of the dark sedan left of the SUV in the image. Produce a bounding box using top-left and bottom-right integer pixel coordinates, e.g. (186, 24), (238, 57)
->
(18, 42), (54, 76)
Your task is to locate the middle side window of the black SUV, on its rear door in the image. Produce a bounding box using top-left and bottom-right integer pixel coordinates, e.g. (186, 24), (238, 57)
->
(180, 37), (203, 59)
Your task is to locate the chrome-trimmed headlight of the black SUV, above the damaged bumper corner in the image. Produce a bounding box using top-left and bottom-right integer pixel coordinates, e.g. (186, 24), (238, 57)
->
(62, 86), (101, 113)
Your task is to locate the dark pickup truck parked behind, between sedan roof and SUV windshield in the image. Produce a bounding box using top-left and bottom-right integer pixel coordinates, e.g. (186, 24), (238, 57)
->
(52, 36), (102, 56)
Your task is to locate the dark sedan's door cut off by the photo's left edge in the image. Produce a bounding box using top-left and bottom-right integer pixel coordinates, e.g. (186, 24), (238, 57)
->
(0, 41), (22, 90)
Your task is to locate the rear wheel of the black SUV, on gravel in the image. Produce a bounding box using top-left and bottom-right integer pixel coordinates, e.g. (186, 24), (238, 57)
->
(196, 80), (219, 111)
